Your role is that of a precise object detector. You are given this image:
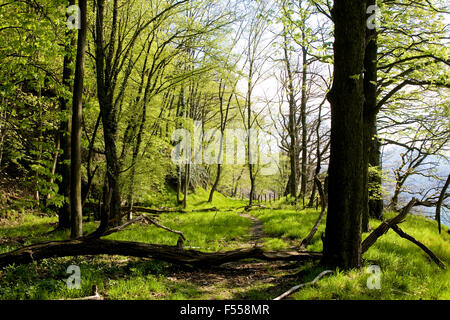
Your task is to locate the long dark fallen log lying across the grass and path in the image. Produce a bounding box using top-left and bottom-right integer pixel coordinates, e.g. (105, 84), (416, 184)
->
(0, 238), (322, 267)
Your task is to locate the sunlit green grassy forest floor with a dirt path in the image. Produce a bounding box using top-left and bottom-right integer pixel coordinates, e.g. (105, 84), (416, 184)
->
(0, 188), (450, 300)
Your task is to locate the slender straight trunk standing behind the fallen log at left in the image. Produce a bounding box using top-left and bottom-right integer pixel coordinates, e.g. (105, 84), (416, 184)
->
(70, 0), (87, 239)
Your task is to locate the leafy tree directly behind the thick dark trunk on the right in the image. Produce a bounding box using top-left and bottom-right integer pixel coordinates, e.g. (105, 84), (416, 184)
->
(363, 0), (448, 231)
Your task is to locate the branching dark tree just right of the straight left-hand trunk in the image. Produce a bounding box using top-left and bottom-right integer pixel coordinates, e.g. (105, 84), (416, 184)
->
(95, 0), (188, 233)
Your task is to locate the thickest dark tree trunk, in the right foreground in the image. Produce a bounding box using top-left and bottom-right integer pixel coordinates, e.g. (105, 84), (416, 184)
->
(323, 0), (366, 269)
